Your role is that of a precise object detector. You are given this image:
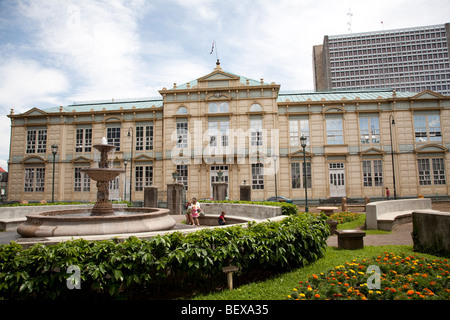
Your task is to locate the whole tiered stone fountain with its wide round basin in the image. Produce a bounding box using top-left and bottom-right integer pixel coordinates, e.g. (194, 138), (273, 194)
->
(17, 138), (176, 238)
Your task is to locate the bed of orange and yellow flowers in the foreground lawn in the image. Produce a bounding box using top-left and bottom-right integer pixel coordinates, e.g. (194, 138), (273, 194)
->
(287, 252), (450, 300)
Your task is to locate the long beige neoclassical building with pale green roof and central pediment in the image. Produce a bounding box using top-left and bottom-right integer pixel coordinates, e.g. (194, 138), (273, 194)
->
(8, 63), (450, 203)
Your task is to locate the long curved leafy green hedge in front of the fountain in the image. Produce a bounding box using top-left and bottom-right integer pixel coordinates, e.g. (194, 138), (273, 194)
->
(0, 214), (329, 299)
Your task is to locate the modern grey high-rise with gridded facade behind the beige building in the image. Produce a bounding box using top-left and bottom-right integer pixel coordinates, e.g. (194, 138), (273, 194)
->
(313, 23), (450, 95)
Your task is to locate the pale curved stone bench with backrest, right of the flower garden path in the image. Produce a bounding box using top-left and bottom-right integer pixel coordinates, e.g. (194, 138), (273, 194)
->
(366, 198), (431, 231)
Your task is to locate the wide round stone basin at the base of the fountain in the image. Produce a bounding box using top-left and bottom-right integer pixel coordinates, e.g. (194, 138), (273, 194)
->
(17, 207), (176, 238)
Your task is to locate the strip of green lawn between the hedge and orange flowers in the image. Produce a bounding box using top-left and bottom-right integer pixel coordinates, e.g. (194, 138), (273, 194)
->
(190, 246), (437, 300)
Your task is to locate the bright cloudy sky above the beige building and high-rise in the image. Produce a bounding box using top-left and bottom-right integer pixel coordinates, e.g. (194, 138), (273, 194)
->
(0, 0), (450, 170)
